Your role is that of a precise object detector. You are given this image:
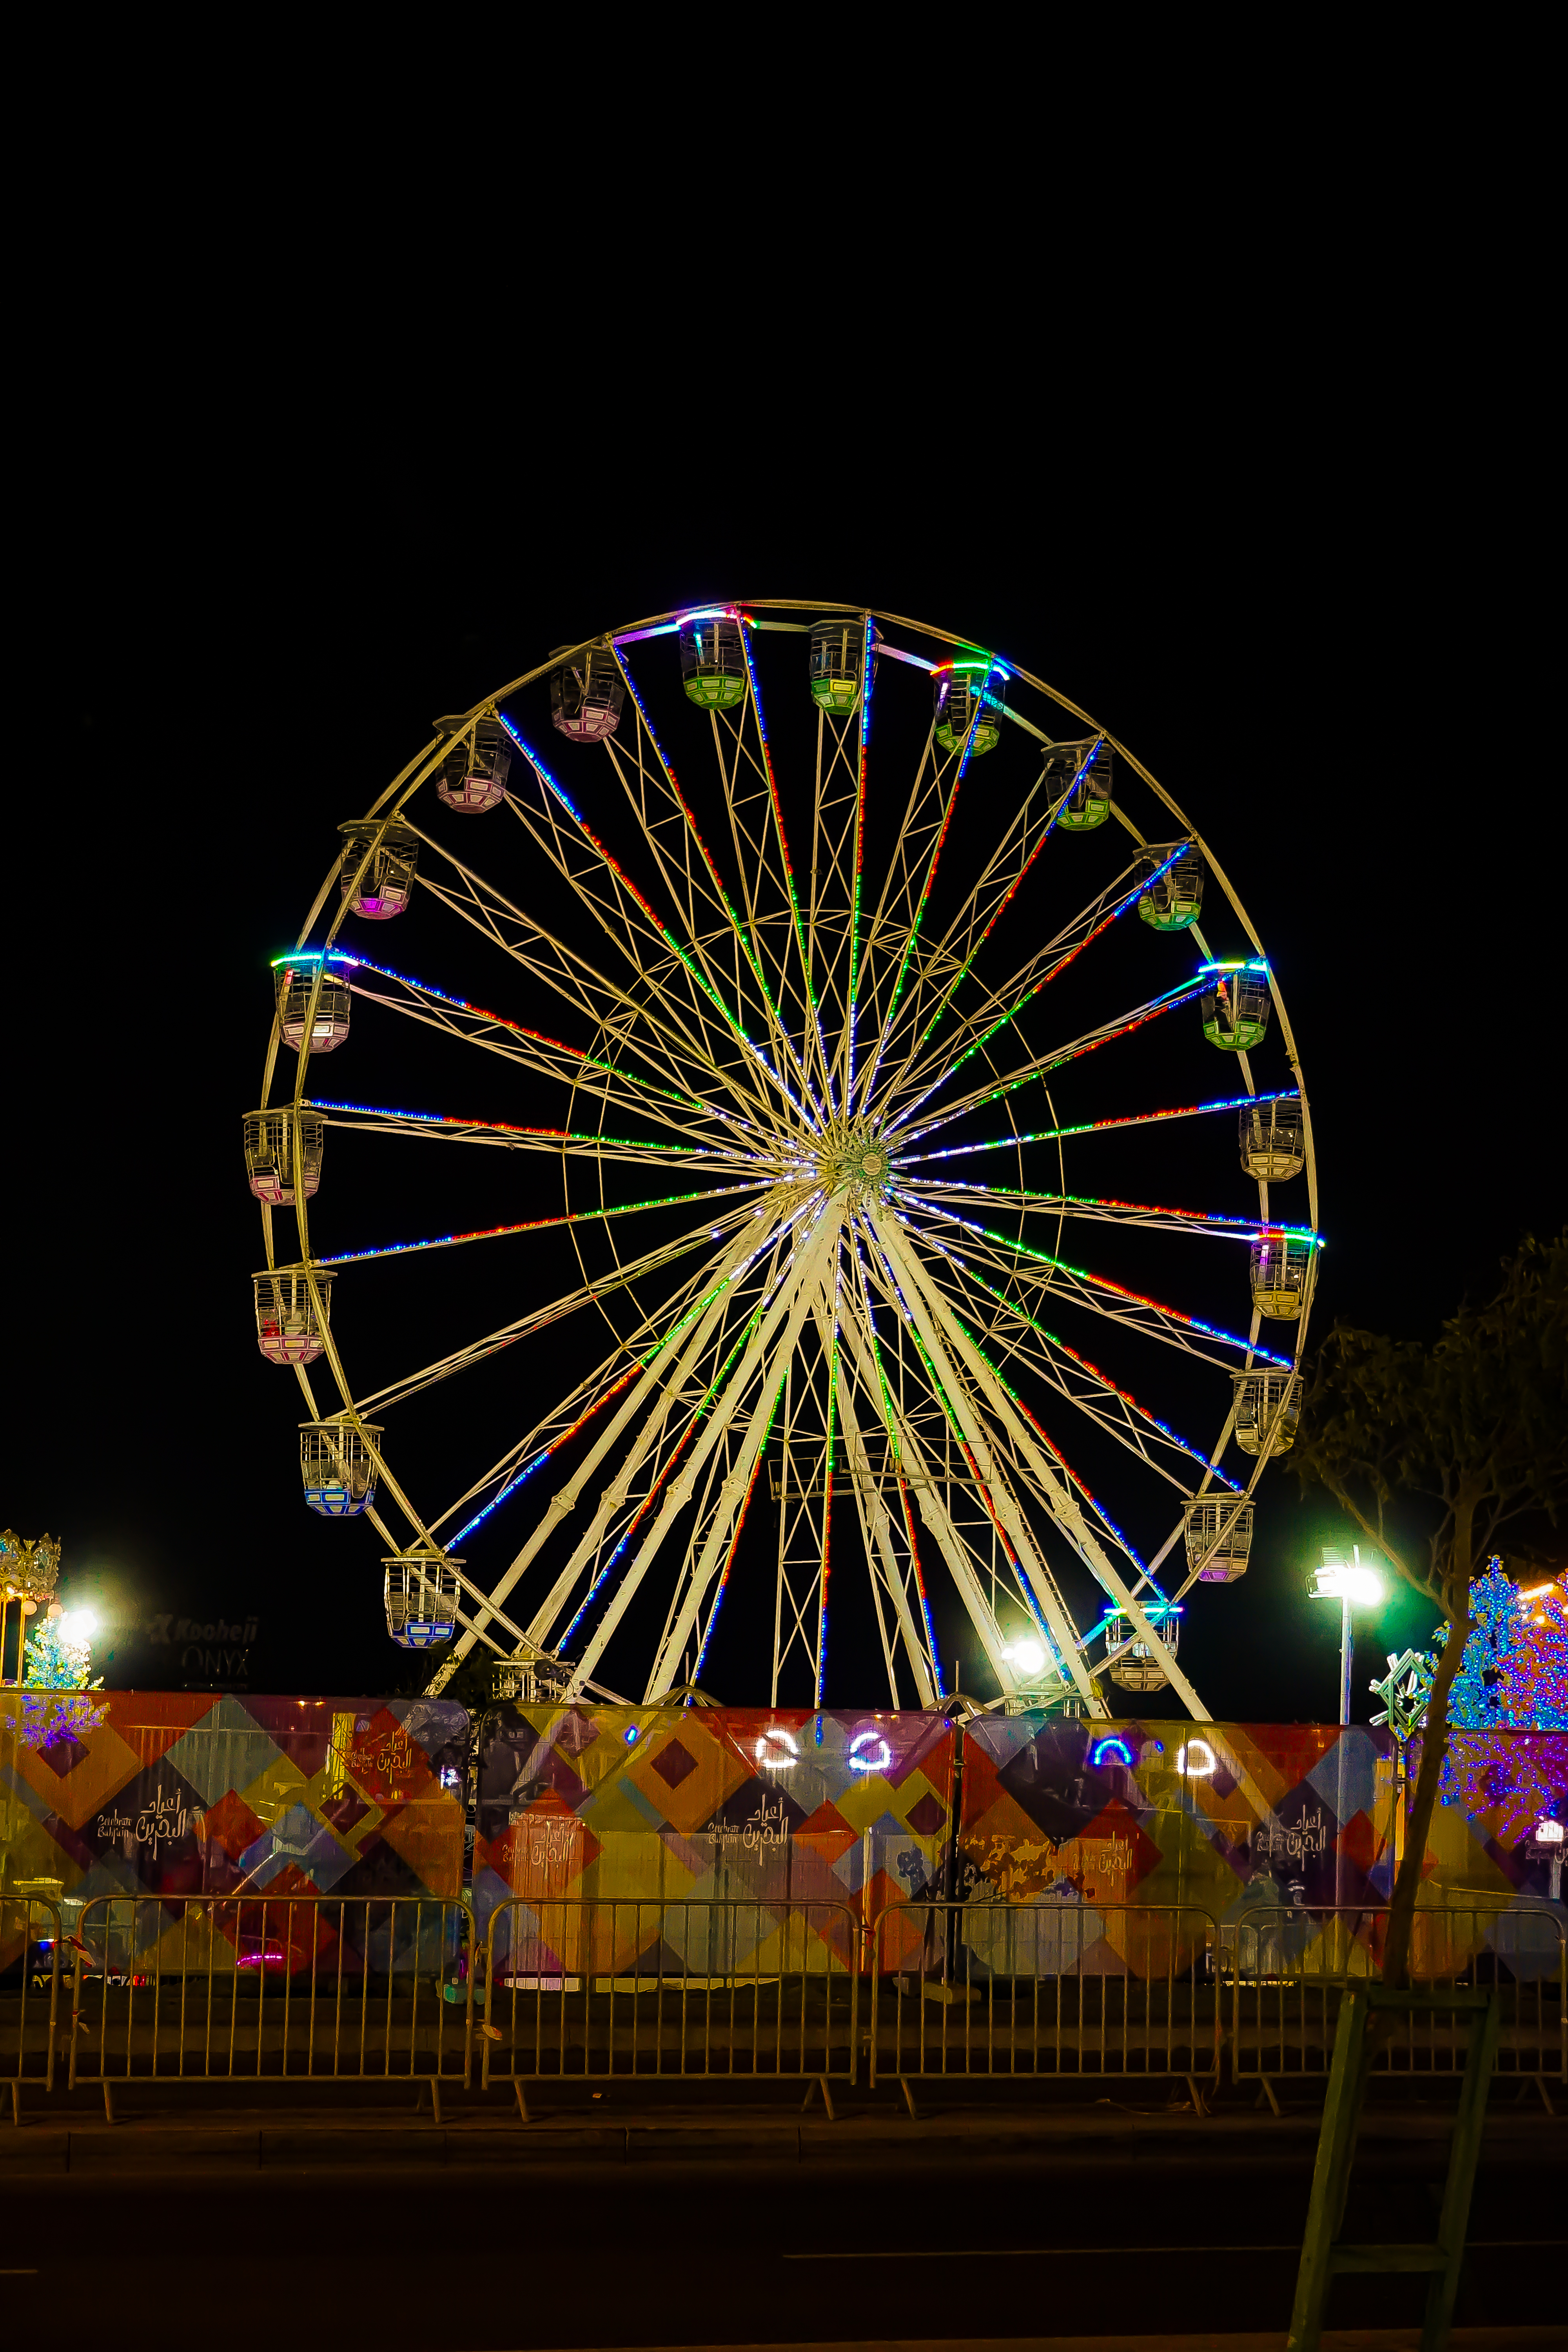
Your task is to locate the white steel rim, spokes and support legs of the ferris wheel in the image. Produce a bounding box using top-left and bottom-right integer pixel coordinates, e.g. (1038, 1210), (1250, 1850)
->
(261, 600), (1319, 1719)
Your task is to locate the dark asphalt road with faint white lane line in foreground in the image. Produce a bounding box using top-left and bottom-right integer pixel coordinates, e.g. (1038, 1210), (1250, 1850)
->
(0, 2117), (1568, 2352)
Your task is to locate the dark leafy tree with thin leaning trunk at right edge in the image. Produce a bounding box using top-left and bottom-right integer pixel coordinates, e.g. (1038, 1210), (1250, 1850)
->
(1295, 1230), (1568, 1985)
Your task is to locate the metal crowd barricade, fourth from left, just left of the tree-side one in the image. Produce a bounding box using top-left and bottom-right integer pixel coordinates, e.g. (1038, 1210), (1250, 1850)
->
(870, 1900), (1222, 2112)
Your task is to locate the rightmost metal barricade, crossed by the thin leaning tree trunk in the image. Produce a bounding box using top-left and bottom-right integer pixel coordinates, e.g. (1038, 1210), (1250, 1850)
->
(1220, 1903), (1568, 2091)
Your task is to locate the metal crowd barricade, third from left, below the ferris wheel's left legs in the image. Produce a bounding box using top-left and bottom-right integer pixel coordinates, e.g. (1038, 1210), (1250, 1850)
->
(479, 1896), (860, 2122)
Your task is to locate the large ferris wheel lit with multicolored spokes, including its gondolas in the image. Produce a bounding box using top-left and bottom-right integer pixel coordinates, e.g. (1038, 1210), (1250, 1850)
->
(245, 600), (1321, 1717)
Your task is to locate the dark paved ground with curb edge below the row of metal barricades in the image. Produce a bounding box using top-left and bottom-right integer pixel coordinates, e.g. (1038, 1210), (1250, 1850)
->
(0, 2098), (1568, 2352)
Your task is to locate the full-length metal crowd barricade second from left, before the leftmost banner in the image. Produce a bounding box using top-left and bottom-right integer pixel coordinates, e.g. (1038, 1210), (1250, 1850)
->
(71, 1893), (472, 2117)
